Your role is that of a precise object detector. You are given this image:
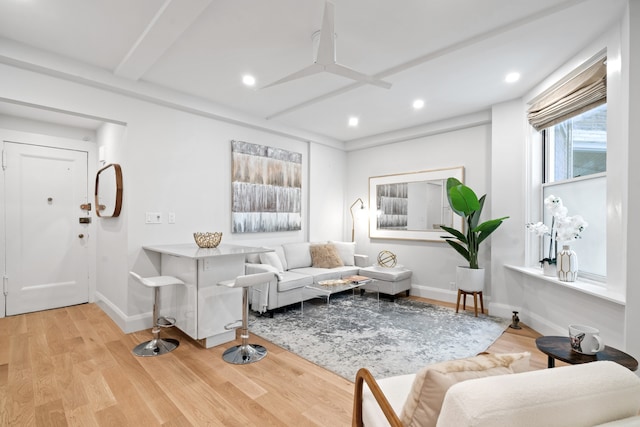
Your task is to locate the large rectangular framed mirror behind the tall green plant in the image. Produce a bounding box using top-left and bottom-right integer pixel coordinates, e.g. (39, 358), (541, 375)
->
(369, 166), (464, 242)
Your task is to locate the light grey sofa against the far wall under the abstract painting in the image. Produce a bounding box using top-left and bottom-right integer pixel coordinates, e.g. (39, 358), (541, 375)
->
(245, 241), (369, 313)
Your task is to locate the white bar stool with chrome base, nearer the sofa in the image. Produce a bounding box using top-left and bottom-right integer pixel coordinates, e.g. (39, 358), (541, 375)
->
(218, 272), (276, 365)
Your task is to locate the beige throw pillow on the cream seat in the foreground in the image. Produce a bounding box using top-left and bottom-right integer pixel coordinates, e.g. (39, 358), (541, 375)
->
(400, 353), (530, 427)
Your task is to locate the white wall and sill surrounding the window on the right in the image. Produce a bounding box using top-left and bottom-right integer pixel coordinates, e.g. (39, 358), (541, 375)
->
(490, 11), (640, 357)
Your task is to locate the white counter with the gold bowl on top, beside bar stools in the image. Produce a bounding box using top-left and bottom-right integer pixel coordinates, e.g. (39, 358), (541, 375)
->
(142, 243), (273, 348)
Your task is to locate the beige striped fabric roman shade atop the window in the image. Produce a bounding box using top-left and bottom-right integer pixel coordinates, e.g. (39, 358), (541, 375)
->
(527, 56), (607, 131)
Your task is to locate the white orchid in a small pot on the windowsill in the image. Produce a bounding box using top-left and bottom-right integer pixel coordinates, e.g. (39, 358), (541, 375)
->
(526, 195), (589, 264)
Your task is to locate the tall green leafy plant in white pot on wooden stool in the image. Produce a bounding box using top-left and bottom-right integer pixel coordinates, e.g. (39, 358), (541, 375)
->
(441, 178), (509, 292)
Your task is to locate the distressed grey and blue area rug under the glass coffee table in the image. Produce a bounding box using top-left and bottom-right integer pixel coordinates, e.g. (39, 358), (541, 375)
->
(251, 292), (510, 381)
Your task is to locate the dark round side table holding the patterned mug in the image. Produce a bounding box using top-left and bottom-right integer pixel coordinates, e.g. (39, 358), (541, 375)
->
(536, 336), (638, 371)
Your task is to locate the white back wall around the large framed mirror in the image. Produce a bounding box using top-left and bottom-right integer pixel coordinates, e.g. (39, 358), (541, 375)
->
(345, 125), (491, 301)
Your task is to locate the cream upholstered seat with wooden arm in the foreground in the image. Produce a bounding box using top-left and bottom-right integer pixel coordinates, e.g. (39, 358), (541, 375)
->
(353, 355), (640, 427)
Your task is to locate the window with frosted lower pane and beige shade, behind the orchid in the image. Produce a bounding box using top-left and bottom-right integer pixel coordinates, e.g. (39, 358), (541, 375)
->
(528, 52), (607, 282)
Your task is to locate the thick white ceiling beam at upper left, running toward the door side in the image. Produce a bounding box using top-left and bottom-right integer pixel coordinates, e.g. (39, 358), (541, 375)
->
(114, 0), (212, 80)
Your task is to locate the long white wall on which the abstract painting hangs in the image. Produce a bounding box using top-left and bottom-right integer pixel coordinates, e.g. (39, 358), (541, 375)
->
(0, 61), (346, 331)
